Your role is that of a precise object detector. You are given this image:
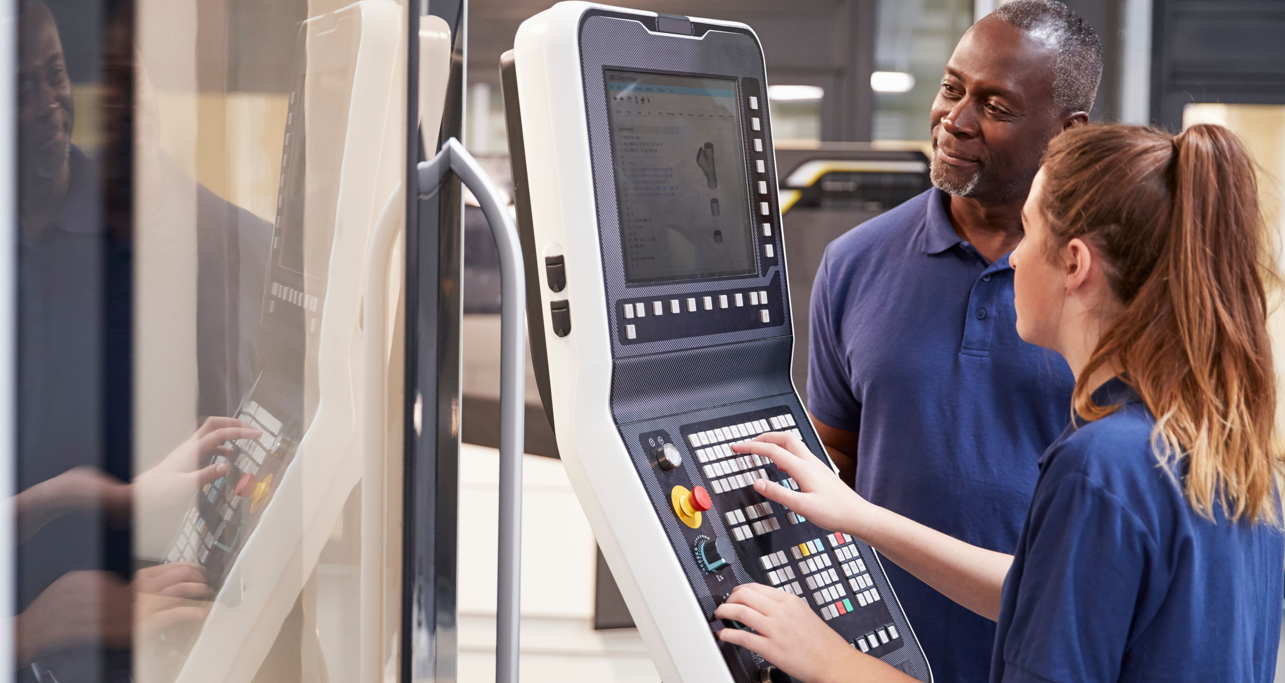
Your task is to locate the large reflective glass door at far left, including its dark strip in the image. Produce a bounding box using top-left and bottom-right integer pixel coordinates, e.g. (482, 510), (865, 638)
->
(14, 0), (407, 683)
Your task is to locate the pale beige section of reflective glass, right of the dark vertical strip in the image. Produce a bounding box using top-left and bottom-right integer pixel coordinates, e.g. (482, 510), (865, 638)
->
(134, 0), (406, 682)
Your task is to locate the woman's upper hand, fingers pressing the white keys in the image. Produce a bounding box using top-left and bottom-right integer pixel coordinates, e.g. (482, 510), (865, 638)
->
(731, 431), (879, 538)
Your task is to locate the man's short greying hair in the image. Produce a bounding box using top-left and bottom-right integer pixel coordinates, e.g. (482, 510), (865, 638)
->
(995, 0), (1103, 112)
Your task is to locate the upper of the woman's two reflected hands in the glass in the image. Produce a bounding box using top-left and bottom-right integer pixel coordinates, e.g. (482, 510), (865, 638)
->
(134, 417), (263, 514)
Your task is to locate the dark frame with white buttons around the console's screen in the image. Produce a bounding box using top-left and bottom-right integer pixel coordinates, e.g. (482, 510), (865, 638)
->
(581, 12), (790, 357)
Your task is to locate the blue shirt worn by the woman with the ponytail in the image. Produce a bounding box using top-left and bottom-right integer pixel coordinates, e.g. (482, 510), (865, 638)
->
(991, 379), (1285, 683)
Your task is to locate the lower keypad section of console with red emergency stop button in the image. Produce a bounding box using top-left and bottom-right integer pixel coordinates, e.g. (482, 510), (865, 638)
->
(636, 406), (915, 674)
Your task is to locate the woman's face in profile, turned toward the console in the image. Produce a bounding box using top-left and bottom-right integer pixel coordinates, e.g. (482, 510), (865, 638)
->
(1009, 171), (1067, 350)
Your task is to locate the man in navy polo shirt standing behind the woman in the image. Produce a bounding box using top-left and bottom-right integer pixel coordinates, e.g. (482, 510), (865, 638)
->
(808, 0), (1103, 682)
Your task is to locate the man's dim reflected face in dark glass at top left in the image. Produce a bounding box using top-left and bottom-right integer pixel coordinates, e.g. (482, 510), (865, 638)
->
(18, 3), (73, 178)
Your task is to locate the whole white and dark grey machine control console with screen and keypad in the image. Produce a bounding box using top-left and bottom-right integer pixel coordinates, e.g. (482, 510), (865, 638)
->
(501, 3), (932, 683)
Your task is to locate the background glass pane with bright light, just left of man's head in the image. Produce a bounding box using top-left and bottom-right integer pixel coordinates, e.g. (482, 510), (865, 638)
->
(870, 0), (973, 140)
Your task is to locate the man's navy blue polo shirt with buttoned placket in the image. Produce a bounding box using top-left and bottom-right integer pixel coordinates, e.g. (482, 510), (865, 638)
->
(808, 189), (1073, 683)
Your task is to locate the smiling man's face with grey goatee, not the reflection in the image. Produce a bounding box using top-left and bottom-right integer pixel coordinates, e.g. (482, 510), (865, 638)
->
(932, 17), (1063, 203)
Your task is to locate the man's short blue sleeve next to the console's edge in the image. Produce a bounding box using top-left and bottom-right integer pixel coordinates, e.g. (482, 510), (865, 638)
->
(807, 249), (861, 431)
